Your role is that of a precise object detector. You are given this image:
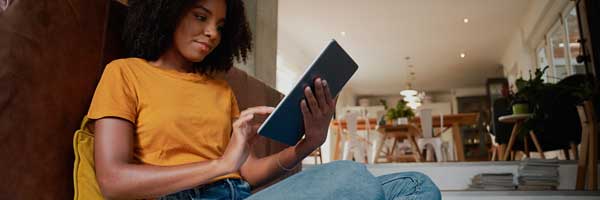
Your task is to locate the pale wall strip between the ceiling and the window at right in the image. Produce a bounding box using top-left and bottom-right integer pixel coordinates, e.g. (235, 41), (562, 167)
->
(501, 0), (569, 85)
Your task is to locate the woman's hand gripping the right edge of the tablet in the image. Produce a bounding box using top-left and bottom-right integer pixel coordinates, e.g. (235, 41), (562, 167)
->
(300, 78), (337, 151)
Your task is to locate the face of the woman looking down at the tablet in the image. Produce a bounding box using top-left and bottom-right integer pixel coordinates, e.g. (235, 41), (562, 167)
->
(173, 0), (227, 62)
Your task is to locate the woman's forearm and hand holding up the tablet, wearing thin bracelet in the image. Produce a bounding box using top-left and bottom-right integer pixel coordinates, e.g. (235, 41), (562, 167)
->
(240, 78), (336, 187)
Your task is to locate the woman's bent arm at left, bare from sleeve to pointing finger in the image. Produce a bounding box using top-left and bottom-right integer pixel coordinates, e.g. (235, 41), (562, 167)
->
(94, 107), (272, 199)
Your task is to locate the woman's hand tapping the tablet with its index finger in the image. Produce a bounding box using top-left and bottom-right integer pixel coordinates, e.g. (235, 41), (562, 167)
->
(221, 106), (274, 173)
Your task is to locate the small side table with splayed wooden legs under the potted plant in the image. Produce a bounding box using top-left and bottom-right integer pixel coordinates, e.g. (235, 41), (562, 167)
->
(498, 114), (545, 161)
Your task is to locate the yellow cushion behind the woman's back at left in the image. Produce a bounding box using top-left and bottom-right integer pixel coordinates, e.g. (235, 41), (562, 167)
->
(73, 117), (104, 200)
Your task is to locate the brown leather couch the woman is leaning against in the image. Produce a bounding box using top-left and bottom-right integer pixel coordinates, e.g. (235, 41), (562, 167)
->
(0, 0), (285, 199)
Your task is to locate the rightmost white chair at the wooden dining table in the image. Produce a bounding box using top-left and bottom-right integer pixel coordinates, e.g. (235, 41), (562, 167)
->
(417, 109), (443, 162)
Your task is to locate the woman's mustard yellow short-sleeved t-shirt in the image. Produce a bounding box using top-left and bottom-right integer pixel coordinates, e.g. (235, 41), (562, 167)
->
(88, 58), (241, 181)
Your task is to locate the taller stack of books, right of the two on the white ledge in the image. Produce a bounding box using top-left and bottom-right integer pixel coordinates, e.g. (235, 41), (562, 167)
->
(517, 159), (559, 190)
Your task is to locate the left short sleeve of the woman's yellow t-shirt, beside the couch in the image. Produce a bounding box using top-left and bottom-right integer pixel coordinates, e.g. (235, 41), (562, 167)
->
(88, 60), (137, 124)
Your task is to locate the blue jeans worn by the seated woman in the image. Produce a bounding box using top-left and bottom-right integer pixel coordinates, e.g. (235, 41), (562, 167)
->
(159, 161), (441, 200)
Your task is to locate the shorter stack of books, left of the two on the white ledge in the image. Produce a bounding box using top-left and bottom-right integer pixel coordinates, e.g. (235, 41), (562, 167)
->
(469, 173), (516, 190)
